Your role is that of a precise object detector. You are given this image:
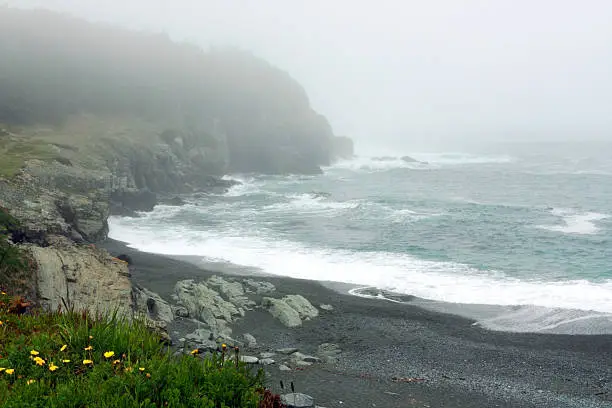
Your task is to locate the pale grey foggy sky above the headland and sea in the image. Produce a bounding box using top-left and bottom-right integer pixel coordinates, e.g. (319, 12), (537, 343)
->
(8, 0), (612, 147)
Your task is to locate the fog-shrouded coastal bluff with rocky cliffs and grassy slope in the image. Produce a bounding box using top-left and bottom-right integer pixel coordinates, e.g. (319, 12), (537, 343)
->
(0, 7), (353, 326)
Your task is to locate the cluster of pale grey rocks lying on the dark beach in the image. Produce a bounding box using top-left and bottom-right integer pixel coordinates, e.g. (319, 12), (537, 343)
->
(132, 275), (330, 354)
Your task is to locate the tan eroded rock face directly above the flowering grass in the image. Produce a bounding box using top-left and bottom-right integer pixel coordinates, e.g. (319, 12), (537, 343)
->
(25, 237), (132, 316)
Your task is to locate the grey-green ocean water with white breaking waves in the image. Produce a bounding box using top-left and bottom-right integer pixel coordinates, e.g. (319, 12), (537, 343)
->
(110, 143), (612, 320)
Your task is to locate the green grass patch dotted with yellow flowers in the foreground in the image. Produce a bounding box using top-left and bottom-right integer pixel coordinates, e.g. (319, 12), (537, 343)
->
(0, 294), (263, 408)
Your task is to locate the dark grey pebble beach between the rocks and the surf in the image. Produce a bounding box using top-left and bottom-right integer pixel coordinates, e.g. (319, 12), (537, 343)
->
(101, 240), (612, 408)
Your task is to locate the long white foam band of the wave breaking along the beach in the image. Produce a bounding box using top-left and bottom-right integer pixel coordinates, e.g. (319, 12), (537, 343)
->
(109, 217), (612, 313)
